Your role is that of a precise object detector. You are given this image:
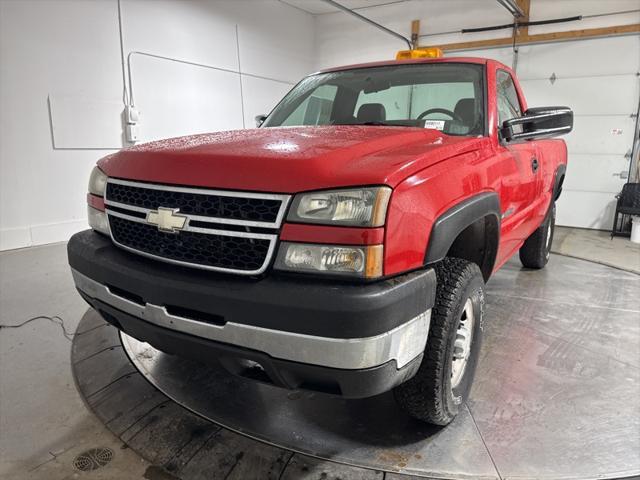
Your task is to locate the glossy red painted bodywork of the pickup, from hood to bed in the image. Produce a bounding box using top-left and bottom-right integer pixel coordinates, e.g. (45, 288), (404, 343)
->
(94, 58), (566, 275)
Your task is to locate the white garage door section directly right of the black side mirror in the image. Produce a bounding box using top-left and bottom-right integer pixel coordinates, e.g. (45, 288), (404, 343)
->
(563, 115), (636, 155)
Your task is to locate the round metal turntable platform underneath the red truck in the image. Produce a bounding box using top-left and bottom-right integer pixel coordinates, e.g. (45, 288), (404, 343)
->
(72, 255), (640, 480)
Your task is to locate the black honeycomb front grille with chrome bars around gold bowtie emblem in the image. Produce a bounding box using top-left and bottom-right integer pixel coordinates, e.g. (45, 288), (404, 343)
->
(105, 179), (289, 275)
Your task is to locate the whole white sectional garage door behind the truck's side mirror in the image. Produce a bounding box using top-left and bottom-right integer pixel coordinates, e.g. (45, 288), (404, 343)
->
(518, 35), (640, 230)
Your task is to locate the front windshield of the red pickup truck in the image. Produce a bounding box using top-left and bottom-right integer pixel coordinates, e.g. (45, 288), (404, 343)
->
(263, 63), (484, 135)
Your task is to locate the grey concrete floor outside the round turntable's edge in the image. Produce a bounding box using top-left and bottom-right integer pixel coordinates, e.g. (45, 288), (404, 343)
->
(0, 229), (640, 480)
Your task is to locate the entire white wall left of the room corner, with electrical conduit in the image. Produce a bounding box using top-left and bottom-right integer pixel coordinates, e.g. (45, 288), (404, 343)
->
(0, 0), (314, 250)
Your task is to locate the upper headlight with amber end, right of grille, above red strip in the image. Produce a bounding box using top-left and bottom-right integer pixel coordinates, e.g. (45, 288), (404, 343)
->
(287, 187), (391, 227)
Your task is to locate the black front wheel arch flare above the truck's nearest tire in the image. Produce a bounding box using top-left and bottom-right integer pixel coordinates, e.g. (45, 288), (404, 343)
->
(424, 192), (500, 281)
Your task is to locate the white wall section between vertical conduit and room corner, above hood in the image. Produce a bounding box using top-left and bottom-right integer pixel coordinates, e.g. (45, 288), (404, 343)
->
(122, 0), (314, 141)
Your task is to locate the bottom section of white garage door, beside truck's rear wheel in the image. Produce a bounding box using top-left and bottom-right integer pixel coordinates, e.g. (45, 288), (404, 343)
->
(556, 190), (616, 230)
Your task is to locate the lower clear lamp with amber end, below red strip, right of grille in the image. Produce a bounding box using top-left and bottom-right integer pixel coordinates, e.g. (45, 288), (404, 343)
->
(275, 242), (383, 278)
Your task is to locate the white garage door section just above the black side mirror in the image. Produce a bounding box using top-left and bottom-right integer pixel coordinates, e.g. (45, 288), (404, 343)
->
(521, 74), (639, 115)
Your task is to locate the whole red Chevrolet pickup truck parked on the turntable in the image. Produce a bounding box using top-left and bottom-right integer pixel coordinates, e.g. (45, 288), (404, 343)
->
(68, 54), (573, 425)
